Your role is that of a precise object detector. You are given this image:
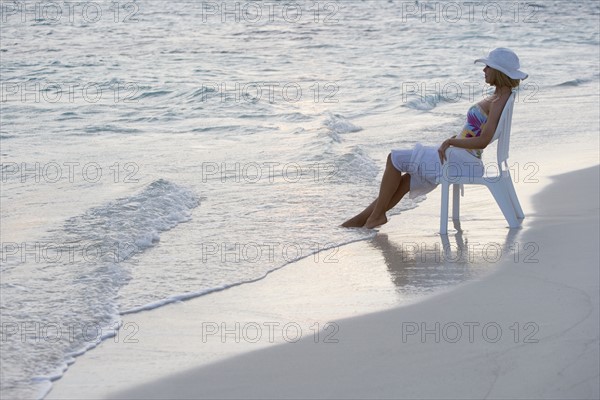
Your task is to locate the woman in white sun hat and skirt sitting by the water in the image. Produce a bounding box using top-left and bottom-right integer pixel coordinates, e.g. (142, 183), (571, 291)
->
(342, 48), (528, 229)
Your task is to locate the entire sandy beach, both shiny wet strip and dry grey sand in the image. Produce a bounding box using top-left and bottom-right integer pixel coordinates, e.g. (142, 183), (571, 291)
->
(46, 142), (600, 399)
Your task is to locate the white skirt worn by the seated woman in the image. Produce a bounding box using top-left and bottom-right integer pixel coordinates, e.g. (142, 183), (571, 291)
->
(391, 143), (484, 199)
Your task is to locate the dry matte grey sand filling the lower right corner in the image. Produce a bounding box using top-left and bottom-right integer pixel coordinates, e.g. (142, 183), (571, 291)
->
(109, 166), (599, 398)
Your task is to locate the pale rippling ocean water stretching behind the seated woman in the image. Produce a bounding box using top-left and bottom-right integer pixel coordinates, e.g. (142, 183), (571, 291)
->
(0, 0), (600, 398)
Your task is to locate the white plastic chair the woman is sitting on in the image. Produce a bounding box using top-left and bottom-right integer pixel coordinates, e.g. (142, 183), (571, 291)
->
(438, 92), (525, 235)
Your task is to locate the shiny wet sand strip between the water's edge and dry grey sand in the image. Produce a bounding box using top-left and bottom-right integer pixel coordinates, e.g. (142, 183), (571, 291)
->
(45, 148), (600, 399)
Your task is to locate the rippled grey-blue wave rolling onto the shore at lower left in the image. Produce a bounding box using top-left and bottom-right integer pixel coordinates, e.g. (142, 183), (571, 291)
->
(2, 179), (200, 400)
